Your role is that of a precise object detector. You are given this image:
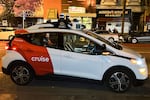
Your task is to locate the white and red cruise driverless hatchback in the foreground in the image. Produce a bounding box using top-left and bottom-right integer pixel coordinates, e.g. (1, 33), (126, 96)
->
(2, 22), (148, 92)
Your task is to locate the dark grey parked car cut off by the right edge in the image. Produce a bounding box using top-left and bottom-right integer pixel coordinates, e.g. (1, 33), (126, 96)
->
(128, 32), (150, 43)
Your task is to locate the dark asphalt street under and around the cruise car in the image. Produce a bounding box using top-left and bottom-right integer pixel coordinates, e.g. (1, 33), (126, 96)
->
(0, 43), (150, 100)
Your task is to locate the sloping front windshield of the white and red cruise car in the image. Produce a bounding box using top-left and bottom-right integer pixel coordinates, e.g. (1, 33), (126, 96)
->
(84, 31), (122, 50)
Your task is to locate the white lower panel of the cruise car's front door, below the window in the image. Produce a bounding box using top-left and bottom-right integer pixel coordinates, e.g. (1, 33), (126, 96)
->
(61, 51), (104, 80)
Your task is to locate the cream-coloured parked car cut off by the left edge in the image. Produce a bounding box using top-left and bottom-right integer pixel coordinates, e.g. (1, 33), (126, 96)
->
(0, 26), (15, 40)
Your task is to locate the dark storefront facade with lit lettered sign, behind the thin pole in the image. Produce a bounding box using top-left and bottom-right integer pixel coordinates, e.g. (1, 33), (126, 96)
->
(96, 0), (145, 33)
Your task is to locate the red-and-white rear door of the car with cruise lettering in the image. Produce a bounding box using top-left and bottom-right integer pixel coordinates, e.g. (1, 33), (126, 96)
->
(13, 33), (60, 75)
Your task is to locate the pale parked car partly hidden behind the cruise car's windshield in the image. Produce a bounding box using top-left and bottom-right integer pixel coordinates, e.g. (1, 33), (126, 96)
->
(94, 30), (123, 42)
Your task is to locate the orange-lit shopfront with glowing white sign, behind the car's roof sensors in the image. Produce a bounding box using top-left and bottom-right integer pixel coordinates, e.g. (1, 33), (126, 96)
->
(62, 0), (96, 29)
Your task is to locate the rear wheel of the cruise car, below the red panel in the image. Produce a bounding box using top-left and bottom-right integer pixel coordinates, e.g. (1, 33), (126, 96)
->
(10, 62), (34, 85)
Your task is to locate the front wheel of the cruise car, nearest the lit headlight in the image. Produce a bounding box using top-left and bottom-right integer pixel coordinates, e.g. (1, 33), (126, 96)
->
(105, 69), (133, 93)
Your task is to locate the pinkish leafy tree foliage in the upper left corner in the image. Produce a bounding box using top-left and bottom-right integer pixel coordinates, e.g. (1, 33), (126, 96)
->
(0, 0), (42, 24)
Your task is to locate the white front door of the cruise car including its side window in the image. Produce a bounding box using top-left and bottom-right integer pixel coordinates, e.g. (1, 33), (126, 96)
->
(60, 34), (103, 79)
